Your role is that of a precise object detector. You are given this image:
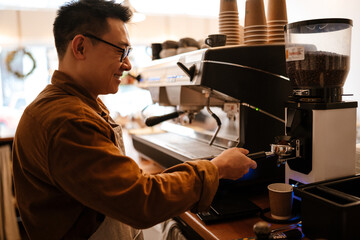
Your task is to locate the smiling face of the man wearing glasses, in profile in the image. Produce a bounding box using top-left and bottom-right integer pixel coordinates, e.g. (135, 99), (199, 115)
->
(85, 18), (131, 96)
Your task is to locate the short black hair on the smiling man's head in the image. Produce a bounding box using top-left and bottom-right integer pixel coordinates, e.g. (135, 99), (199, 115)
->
(53, 0), (132, 59)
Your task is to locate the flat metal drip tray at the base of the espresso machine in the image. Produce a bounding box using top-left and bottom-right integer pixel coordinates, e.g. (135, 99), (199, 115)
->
(138, 132), (224, 160)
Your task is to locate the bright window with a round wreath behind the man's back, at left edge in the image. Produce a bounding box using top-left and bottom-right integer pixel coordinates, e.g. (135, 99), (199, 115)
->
(0, 46), (57, 137)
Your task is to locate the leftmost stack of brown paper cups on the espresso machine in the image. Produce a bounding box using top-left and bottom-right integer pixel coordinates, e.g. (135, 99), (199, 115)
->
(219, 0), (241, 45)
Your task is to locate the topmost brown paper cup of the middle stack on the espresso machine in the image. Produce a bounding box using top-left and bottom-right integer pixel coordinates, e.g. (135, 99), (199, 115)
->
(245, 0), (266, 27)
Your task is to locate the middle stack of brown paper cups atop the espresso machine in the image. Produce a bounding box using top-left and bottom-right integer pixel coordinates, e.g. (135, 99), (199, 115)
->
(244, 0), (267, 44)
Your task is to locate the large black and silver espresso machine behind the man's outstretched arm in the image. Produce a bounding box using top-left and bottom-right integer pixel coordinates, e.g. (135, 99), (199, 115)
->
(132, 44), (291, 222)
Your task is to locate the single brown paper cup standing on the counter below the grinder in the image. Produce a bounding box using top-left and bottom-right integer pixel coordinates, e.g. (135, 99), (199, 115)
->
(268, 183), (293, 220)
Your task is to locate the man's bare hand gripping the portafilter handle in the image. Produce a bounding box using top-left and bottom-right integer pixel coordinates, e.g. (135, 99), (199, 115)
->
(211, 148), (257, 180)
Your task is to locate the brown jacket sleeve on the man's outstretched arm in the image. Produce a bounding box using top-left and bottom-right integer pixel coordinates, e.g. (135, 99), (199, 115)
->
(48, 119), (219, 228)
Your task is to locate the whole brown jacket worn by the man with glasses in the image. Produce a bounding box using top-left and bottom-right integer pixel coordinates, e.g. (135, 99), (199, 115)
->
(13, 71), (219, 239)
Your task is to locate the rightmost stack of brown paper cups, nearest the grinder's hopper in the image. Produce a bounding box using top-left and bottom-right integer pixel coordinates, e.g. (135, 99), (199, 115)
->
(267, 0), (287, 43)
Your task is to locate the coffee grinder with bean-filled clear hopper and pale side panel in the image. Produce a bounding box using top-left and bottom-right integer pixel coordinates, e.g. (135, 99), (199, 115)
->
(272, 19), (357, 185)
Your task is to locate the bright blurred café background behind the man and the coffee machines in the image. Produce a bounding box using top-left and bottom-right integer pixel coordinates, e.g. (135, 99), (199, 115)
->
(0, 0), (360, 142)
